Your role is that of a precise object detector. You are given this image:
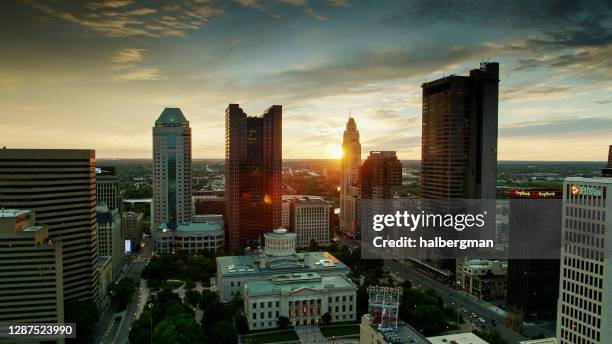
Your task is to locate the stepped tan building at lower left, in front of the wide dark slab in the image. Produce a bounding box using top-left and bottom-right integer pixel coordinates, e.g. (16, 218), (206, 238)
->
(0, 208), (64, 323)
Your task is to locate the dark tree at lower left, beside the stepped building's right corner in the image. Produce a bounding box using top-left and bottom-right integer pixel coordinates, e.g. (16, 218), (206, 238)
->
(65, 301), (100, 343)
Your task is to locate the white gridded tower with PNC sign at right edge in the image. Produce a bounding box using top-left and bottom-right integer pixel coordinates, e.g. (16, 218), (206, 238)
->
(557, 178), (612, 344)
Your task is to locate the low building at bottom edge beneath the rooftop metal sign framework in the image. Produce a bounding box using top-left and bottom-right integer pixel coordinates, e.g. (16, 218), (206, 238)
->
(359, 314), (429, 344)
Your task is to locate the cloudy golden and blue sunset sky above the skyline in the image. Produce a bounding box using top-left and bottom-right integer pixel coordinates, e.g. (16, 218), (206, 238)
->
(0, 0), (612, 160)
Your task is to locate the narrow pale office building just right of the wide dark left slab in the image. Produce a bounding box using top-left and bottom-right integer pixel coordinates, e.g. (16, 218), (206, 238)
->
(96, 205), (125, 281)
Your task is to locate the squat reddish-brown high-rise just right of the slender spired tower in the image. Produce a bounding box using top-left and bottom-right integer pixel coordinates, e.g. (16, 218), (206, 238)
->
(360, 151), (402, 199)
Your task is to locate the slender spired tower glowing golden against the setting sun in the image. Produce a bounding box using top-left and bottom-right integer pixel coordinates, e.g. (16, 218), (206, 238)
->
(340, 117), (361, 233)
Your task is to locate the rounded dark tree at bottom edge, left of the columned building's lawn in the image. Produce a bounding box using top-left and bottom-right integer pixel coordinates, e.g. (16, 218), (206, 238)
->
(153, 314), (205, 344)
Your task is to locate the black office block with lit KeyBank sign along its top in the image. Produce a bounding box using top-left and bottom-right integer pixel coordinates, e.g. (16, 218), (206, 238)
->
(505, 189), (563, 330)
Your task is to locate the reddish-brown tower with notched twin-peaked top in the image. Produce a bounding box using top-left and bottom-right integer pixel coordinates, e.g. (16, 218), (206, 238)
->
(225, 104), (283, 249)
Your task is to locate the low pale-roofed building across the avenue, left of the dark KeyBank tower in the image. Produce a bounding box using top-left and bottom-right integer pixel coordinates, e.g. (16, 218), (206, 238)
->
(457, 258), (508, 300)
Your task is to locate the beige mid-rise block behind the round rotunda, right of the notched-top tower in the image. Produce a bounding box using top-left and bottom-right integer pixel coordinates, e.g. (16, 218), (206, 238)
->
(283, 195), (333, 248)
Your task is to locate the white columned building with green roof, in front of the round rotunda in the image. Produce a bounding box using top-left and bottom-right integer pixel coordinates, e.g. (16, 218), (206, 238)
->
(242, 272), (357, 330)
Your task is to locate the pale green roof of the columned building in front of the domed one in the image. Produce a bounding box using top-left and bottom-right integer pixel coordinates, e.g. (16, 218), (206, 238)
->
(244, 273), (355, 294)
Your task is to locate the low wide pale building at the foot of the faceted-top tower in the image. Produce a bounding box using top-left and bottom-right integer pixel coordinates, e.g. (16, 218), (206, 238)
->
(151, 215), (225, 254)
